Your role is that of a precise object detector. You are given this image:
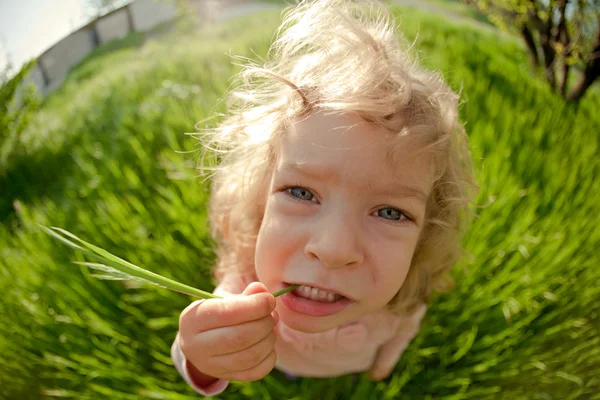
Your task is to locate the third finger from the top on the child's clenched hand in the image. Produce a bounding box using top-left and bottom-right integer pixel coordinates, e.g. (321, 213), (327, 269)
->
(210, 332), (276, 373)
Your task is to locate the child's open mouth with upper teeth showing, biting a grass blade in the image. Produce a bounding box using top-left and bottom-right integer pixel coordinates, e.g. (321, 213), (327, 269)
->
(281, 283), (353, 317)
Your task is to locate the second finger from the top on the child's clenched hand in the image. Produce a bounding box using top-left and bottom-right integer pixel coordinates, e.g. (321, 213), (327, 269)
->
(197, 315), (275, 356)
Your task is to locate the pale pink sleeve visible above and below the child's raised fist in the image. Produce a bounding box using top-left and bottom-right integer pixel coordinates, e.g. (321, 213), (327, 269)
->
(171, 274), (252, 396)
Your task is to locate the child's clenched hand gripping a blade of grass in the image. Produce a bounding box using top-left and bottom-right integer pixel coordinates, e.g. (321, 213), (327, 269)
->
(179, 282), (279, 381)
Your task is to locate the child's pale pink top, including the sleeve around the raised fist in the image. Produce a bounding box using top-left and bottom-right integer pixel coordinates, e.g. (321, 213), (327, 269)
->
(171, 274), (427, 396)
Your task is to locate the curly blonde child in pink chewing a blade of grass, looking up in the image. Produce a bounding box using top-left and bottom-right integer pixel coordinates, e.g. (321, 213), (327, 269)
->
(172, 0), (477, 395)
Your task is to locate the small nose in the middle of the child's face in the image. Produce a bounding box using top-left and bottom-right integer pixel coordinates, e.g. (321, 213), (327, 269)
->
(304, 206), (364, 268)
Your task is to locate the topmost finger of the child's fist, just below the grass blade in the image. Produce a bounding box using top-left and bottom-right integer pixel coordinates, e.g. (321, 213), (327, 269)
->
(179, 292), (275, 339)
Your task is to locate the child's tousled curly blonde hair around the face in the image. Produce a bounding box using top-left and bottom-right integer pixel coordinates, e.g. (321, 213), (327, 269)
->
(198, 0), (478, 313)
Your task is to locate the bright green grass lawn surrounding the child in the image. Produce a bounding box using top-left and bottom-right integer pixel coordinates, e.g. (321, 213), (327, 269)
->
(0, 3), (600, 399)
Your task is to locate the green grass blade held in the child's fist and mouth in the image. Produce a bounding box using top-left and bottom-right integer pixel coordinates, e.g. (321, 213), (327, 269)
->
(39, 225), (300, 299)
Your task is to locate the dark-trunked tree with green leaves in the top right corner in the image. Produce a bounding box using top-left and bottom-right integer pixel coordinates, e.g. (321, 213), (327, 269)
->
(463, 0), (600, 102)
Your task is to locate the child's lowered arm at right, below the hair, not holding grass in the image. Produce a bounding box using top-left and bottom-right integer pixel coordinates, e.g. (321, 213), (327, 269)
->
(367, 304), (427, 381)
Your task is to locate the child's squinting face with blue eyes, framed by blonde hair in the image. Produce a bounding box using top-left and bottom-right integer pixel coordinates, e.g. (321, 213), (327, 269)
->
(255, 114), (432, 332)
